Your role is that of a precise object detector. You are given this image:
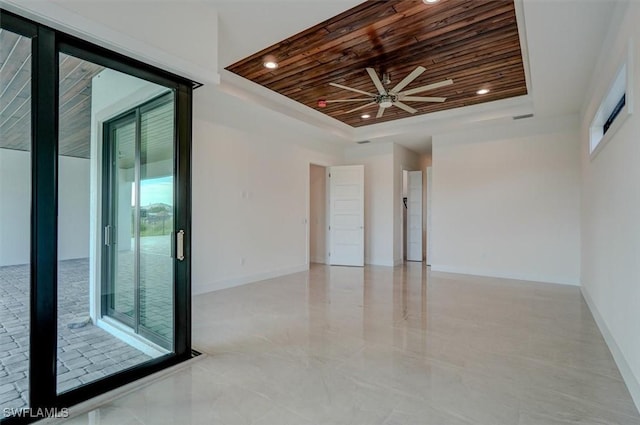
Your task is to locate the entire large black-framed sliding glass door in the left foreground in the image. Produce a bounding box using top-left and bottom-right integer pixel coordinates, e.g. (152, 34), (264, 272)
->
(0, 9), (194, 425)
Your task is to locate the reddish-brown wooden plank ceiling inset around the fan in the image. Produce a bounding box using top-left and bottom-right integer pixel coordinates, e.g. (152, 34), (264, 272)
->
(226, 0), (527, 127)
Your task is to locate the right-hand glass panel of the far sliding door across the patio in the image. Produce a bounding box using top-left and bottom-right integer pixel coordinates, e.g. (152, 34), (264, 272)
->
(140, 94), (175, 349)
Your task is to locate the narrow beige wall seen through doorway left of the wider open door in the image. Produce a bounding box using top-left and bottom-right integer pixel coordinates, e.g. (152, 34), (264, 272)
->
(309, 164), (327, 263)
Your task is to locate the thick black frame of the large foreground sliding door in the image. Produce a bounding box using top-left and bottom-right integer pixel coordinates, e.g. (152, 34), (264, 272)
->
(0, 9), (199, 425)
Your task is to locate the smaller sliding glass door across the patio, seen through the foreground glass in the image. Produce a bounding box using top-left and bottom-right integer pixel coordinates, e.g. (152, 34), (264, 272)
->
(103, 93), (175, 350)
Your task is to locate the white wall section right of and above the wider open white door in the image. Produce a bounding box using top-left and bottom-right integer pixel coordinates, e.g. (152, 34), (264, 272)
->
(345, 143), (402, 266)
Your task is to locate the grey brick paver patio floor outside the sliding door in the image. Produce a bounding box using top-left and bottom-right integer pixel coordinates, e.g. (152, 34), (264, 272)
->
(0, 259), (155, 408)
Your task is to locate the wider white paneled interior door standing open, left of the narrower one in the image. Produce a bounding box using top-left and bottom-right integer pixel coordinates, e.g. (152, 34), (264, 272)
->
(329, 165), (364, 267)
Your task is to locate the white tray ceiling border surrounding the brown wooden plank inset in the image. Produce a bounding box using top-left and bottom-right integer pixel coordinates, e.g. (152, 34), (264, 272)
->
(213, 0), (619, 153)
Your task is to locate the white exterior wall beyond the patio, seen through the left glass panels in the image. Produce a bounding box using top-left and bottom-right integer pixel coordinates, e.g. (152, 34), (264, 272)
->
(0, 149), (90, 266)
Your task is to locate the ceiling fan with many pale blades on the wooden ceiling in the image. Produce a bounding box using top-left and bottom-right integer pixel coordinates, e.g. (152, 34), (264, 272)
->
(318, 66), (453, 118)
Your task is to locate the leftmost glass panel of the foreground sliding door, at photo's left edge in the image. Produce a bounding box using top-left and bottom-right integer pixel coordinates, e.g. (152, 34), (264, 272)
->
(0, 29), (31, 412)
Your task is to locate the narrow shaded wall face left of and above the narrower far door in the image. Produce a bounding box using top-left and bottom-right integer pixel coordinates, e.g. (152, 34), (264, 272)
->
(393, 143), (420, 265)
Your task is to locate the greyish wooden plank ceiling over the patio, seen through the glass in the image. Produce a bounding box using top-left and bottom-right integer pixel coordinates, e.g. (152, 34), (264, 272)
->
(0, 29), (104, 158)
